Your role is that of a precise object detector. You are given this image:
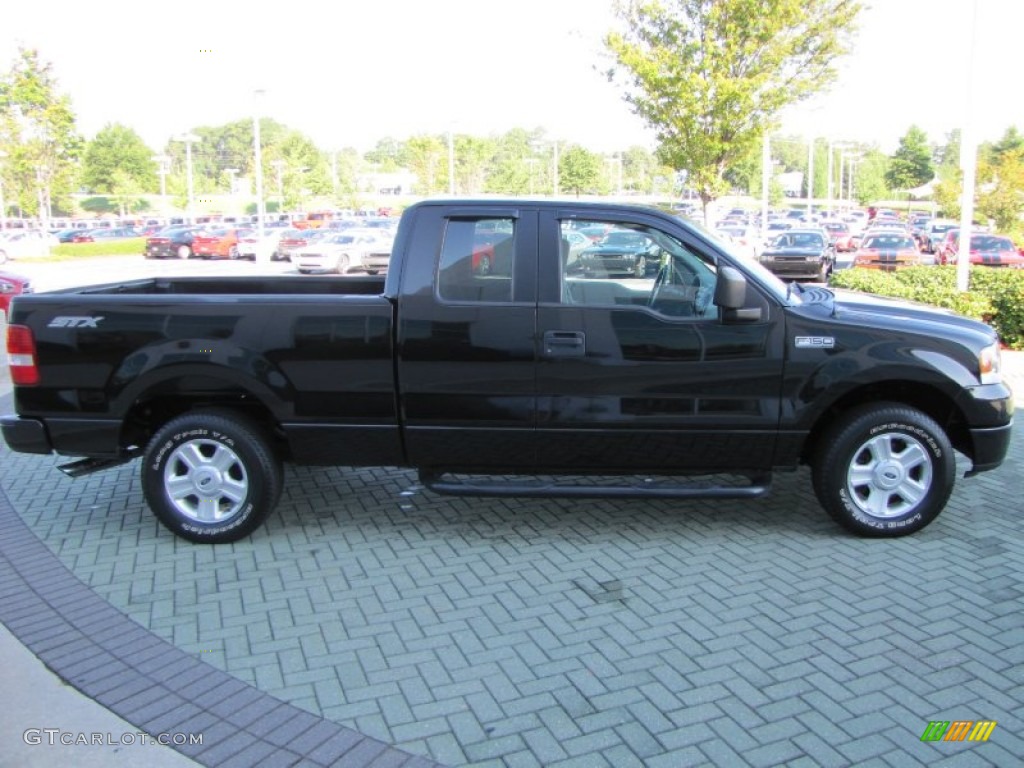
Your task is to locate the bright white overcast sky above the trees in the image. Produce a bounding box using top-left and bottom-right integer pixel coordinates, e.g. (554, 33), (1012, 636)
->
(0, 0), (1024, 153)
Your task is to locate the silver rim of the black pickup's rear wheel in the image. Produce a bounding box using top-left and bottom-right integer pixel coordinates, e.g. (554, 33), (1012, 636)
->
(164, 440), (249, 523)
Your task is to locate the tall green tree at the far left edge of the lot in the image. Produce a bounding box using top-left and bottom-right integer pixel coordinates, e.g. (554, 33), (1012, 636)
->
(0, 48), (82, 227)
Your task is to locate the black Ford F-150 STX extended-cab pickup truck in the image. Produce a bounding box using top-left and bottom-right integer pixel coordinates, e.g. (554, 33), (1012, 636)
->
(2, 200), (1014, 543)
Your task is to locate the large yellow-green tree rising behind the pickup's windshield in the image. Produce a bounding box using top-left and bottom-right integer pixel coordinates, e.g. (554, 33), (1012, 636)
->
(605, 0), (861, 218)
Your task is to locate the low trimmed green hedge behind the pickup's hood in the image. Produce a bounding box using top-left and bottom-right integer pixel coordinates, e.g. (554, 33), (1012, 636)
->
(830, 266), (1024, 349)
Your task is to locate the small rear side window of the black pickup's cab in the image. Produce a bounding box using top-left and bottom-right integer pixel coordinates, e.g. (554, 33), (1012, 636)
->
(437, 218), (515, 302)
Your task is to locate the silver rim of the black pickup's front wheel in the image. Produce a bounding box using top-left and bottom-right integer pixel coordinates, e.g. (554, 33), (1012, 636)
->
(846, 432), (933, 519)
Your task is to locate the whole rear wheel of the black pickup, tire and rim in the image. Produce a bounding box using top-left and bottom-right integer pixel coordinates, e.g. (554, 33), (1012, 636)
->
(141, 410), (282, 544)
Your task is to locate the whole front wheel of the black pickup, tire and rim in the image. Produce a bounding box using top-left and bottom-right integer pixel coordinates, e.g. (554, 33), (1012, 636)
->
(812, 402), (956, 537)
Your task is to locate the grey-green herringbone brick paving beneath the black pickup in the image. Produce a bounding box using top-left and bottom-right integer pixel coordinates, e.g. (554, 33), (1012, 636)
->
(0, 357), (1024, 768)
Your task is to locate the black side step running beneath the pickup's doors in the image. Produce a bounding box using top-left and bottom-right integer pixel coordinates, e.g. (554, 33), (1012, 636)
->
(420, 470), (771, 499)
